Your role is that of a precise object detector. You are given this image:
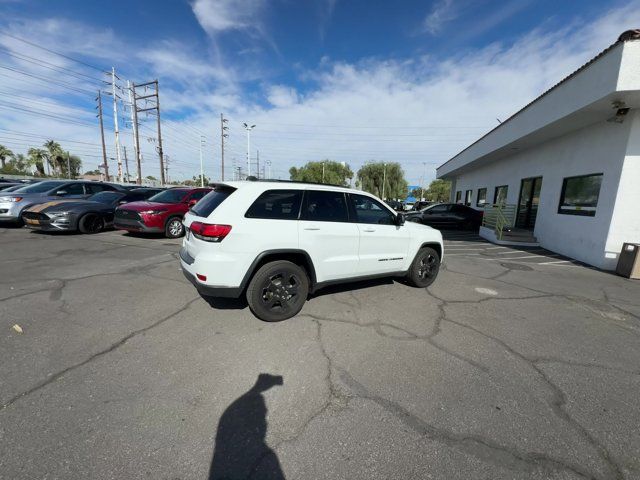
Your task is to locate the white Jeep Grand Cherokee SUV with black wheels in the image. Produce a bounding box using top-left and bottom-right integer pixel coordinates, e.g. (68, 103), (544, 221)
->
(180, 181), (443, 322)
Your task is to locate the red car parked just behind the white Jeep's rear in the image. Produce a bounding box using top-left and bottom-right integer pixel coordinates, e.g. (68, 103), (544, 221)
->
(113, 187), (212, 238)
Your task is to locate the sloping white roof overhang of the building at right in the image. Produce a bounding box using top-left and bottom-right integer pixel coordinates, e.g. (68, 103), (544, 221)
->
(437, 30), (640, 178)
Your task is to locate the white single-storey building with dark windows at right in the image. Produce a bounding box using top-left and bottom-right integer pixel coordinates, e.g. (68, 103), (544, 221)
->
(437, 30), (640, 270)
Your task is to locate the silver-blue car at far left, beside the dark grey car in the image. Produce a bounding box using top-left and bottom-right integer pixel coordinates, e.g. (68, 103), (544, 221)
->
(0, 180), (120, 224)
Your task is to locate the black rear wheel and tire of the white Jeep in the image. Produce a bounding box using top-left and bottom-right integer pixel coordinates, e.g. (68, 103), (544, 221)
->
(247, 260), (309, 322)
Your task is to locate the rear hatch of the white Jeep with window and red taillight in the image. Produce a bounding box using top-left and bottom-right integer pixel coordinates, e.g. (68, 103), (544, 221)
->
(183, 184), (236, 261)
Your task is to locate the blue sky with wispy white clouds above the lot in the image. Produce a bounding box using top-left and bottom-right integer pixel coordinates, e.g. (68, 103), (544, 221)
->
(0, 0), (640, 185)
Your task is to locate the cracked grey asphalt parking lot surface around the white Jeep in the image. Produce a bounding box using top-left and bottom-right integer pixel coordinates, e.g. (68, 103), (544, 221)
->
(0, 228), (640, 480)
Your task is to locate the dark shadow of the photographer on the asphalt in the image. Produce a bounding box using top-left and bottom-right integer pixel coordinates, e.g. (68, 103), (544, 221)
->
(209, 373), (285, 480)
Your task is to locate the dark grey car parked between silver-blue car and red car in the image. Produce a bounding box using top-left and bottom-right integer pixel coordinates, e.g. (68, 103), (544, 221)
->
(22, 190), (159, 233)
